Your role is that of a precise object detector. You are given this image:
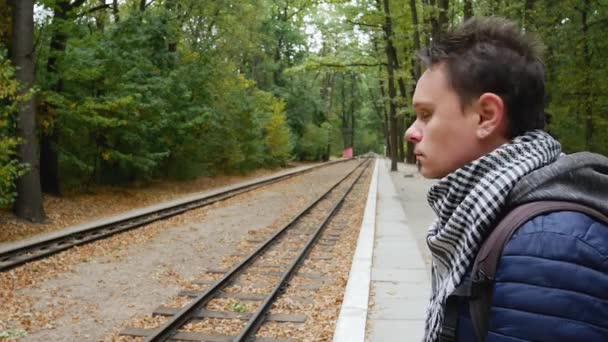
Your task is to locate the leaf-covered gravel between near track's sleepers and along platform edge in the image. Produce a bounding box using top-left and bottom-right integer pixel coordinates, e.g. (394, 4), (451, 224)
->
(115, 162), (371, 341)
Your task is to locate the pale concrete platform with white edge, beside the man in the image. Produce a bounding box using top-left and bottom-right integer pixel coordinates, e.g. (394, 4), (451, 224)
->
(334, 159), (434, 342)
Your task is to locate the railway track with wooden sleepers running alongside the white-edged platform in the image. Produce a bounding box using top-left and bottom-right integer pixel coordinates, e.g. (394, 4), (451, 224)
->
(120, 160), (371, 342)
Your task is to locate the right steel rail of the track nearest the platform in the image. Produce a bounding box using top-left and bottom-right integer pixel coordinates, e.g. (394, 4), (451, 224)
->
(234, 158), (369, 342)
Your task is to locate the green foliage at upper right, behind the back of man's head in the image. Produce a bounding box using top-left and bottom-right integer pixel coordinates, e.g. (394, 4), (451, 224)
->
(532, 0), (608, 155)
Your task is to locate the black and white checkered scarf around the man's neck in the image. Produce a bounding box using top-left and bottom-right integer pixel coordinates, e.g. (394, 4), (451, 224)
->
(424, 130), (561, 342)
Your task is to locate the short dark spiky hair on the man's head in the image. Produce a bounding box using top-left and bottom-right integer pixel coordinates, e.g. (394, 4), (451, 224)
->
(418, 17), (545, 138)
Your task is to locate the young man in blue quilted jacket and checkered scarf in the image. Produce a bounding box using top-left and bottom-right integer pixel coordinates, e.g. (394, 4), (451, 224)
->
(406, 18), (608, 341)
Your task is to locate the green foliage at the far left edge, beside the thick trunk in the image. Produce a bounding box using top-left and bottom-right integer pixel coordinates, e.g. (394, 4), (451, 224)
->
(0, 46), (29, 208)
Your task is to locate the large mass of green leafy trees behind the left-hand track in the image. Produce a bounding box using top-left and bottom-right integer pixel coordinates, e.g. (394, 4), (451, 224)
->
(33, 7), (291, 187)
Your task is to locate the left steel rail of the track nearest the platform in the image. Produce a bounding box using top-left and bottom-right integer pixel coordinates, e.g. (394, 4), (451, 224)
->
(144, 161), (369, 342)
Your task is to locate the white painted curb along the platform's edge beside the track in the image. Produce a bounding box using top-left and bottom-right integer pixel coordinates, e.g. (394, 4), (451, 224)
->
(334, 159), (379, 342)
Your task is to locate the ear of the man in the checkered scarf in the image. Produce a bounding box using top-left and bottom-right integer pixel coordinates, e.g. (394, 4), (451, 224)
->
(476, 93), (506, 140)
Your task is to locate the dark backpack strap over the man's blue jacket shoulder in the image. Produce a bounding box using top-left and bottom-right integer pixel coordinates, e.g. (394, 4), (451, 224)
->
(469, 201), (608, 341)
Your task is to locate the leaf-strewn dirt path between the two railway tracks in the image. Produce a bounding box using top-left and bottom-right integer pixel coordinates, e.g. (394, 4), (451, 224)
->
(0, 162), (354, 341)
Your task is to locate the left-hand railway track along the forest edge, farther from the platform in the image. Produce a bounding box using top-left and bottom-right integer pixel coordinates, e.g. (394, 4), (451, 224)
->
(0, 160), (352, 272)
